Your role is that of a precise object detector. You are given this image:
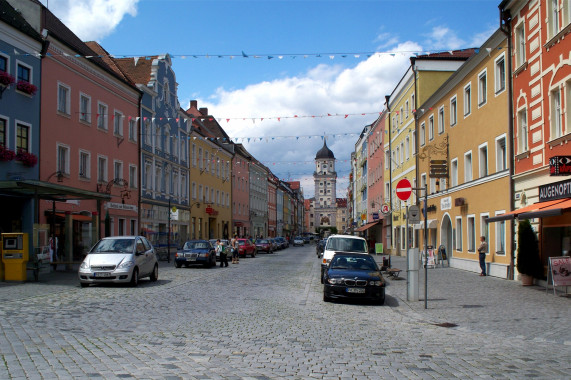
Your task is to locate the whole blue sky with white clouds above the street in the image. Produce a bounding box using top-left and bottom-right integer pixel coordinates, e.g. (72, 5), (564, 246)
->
(41, 0), (500, 198)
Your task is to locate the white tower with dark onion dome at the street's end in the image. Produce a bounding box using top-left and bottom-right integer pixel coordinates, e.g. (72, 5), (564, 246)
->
(313, 139), (337, 228)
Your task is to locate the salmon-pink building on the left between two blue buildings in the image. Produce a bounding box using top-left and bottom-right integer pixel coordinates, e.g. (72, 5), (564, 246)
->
(39, 7), (140, 265)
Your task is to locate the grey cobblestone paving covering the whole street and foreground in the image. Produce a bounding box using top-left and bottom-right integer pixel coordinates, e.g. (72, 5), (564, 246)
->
(0, 246), (571, 379)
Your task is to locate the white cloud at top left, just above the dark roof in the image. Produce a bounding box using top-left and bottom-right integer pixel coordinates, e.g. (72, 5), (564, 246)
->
(41, 0), (139, 41)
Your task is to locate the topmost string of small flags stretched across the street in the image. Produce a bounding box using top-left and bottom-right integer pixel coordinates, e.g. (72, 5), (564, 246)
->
(6, 46), (507, 61)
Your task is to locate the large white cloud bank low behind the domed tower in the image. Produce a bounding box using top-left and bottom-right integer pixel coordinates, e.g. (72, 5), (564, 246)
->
(194, 42), (421, 197)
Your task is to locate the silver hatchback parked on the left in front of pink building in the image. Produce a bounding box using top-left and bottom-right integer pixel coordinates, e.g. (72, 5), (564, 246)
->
(78, 236), (159, 288)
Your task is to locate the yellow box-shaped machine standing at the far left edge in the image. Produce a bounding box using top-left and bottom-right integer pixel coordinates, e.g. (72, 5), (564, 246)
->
(2, 232), (29, 281)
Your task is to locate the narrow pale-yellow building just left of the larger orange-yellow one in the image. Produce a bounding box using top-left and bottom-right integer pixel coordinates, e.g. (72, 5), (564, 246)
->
(385, 49), (474, 255)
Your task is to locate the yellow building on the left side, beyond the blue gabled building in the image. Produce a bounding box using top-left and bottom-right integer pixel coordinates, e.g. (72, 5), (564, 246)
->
(187, 115), (232, 239)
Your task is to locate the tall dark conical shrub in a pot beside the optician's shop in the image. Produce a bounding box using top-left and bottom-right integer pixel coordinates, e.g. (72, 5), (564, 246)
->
(517, 219), (543, 286)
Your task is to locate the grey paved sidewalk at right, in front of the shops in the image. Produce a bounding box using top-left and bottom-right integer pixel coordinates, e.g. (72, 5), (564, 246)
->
(378, 256), (571, 345)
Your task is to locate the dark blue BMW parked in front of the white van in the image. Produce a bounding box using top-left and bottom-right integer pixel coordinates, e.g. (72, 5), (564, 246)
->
(323, 253), (385, 305)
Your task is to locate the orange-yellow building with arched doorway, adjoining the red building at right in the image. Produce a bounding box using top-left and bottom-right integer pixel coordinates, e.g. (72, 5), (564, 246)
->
(415, 30), (511, 277)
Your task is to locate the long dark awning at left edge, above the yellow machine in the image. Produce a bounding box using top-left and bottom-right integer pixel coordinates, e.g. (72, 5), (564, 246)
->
(0, 180), (111, 202)
